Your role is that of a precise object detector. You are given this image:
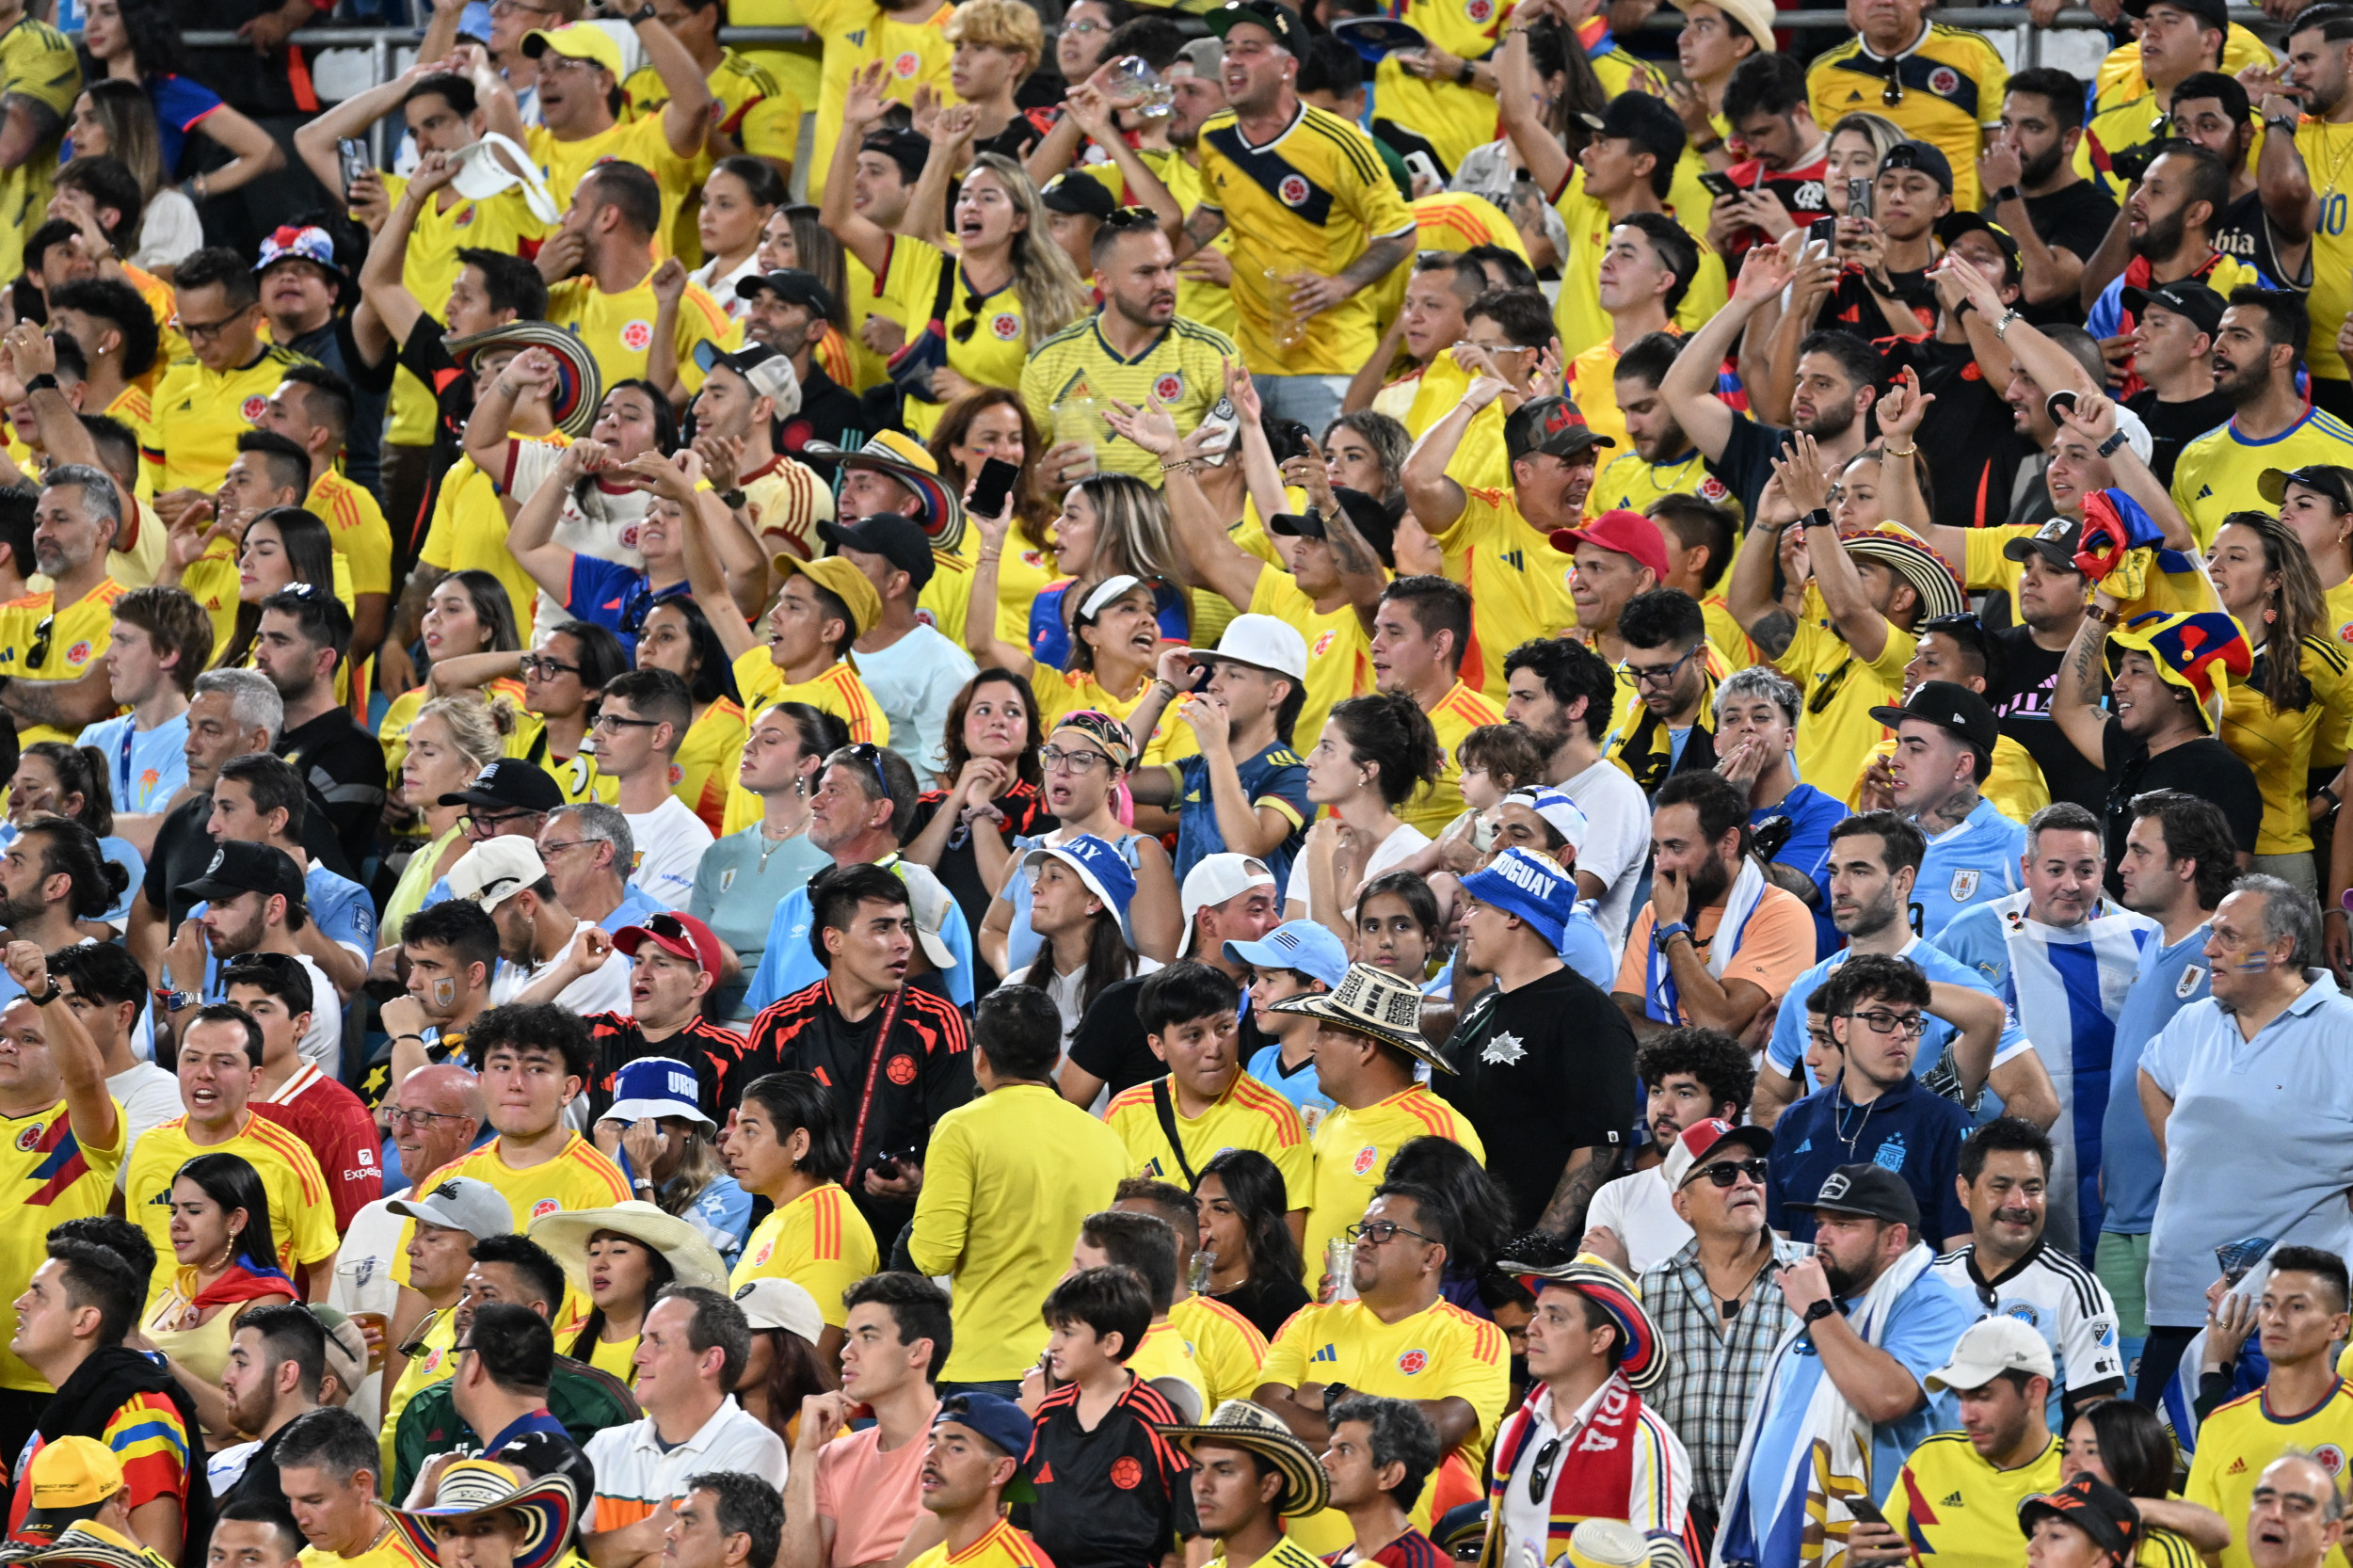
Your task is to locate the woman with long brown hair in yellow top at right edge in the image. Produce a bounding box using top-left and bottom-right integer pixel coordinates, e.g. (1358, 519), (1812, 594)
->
(2207, 511), (2353, 892)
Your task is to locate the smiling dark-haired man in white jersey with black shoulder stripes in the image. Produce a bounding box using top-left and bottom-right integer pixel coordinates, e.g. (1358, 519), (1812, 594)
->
(1937, 1116), (2127, 1429)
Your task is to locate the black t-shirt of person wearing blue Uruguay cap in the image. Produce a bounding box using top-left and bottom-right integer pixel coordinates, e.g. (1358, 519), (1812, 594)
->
(1431, 968), (1642, 1231)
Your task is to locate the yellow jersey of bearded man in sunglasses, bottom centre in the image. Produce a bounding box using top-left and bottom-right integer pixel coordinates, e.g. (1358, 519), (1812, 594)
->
(1261, 1289), (1511, 1549)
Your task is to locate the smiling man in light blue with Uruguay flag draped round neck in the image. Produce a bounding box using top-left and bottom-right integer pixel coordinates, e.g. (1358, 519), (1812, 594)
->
(1937, 801), (2158, 1257)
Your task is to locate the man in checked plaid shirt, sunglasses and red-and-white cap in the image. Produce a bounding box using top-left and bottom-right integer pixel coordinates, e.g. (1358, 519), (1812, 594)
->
(1641, 1118), (1815, 1542)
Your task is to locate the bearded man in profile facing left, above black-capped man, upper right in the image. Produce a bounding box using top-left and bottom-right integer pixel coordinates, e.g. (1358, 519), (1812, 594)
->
(2083, 141), (2268, 398)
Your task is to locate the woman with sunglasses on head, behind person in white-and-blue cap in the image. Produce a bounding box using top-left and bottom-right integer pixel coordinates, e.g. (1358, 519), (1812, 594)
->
(972, 709), (1184, 975)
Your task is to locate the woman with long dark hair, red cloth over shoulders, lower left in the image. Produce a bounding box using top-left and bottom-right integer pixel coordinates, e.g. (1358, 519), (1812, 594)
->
(141, 1154), (301, 1432)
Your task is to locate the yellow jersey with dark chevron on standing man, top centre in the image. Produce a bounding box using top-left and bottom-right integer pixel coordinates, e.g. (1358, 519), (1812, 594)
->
(1200, 104), (1415, 376)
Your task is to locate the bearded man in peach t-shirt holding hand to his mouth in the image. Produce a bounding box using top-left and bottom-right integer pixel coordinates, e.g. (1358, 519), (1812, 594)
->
(1614, 770), (1815, 1038)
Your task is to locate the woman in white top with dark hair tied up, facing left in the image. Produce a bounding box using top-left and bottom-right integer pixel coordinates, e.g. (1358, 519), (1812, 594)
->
(1283, 692), (1445, 947)
